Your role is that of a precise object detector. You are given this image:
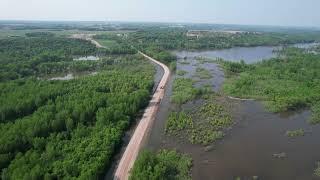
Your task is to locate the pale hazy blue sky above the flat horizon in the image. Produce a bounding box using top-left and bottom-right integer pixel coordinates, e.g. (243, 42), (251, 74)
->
(0, 0), (320, 27)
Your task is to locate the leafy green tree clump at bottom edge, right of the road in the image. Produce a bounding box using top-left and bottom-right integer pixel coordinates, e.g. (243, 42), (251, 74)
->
(129, 150), (192, 180)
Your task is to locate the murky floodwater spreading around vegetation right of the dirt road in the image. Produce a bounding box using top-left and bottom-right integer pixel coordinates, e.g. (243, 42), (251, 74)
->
(146, 44), (320, 180)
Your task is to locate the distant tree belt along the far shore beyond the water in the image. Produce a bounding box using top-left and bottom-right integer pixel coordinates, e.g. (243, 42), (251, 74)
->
(128, 28), (320, 50)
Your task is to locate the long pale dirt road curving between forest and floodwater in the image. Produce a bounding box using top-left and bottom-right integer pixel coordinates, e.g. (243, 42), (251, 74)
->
(114, 51), (170, 180)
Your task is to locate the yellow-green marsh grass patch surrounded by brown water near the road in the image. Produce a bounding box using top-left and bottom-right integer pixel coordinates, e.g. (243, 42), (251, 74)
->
(166, 93), (233, 145)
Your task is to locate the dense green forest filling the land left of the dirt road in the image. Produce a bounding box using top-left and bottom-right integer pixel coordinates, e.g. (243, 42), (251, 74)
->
(0, 33), (154, 179)
